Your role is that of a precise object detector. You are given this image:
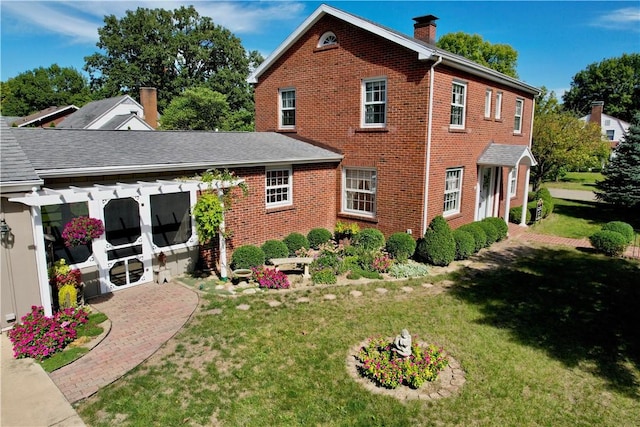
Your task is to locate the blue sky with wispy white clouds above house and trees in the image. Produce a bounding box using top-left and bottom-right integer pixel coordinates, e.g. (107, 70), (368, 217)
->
(0, 0), (640, 95)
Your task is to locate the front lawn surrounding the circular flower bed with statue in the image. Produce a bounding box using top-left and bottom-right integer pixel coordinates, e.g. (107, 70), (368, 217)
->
(77, 245), (640, 426)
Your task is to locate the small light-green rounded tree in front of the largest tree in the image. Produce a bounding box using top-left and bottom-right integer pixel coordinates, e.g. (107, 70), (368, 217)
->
(161, 87), (231, 130)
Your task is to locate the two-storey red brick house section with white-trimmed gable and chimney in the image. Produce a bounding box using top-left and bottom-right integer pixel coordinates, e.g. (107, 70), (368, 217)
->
(249, 5), (539, 237)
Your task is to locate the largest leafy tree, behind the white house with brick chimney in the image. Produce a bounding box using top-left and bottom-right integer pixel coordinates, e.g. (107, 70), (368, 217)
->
(84, 6), (262, 129)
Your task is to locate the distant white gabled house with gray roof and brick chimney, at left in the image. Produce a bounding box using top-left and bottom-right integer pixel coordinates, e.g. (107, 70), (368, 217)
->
(58, 88), (158, 130)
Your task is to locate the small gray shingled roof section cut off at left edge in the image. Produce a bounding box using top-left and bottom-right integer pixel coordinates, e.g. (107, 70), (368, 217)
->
(0, 118), (42, 190)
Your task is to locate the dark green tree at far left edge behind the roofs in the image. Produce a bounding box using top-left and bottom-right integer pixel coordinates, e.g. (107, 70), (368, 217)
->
(0, 64), (91, 116)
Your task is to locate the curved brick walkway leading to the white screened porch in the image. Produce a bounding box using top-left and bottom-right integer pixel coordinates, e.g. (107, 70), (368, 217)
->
(49, 283), (198, 403)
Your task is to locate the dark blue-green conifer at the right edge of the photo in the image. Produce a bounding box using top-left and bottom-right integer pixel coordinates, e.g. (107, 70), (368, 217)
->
(596, 113), (640, 210)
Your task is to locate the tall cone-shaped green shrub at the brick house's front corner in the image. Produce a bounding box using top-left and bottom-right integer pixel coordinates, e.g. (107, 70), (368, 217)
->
(416, 215), (456, 266)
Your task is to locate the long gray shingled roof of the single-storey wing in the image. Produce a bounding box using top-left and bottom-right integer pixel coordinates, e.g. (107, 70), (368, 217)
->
(6, 128), (342, 178)
